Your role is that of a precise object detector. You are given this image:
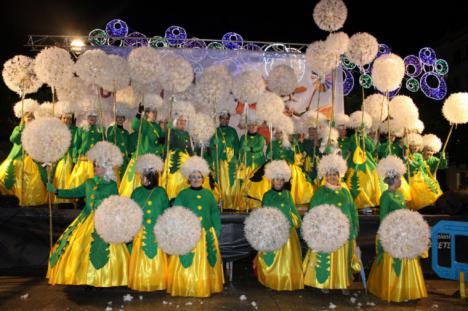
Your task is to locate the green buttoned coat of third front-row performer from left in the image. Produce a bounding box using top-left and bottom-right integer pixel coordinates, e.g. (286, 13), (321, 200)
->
(174, 188), (221, 268)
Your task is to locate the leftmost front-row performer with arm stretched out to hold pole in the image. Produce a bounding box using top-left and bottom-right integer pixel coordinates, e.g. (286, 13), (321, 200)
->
(47, 141), (129, 287)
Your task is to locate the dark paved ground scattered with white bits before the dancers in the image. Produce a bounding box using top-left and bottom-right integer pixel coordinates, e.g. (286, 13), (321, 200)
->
(0, 262), (468, 311)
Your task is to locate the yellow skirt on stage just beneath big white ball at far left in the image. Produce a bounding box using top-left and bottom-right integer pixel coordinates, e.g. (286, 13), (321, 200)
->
(12, 155), (47, 206)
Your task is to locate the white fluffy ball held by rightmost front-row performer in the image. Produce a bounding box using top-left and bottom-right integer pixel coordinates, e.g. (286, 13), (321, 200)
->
(378, 209), (431, 259)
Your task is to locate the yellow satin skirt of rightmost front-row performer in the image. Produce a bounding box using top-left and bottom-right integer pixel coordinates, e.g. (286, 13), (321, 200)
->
(367, 252), (427, 302)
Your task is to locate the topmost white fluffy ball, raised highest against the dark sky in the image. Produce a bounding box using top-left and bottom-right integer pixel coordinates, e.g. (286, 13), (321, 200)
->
(313, 0), (348, 32)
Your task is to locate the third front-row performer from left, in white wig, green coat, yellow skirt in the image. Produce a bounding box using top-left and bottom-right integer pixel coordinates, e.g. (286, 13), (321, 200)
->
(167, 156), (224, 297)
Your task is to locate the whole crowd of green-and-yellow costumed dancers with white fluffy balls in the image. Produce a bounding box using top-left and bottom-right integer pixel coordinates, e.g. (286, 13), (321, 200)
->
(0, 0), (468, 301)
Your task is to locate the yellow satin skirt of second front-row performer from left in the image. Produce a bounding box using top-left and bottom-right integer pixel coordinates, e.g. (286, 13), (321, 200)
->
(128, 228), (168, 292)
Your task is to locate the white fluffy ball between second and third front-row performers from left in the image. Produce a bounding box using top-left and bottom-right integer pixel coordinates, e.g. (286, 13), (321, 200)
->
(154, 206), (201, 255)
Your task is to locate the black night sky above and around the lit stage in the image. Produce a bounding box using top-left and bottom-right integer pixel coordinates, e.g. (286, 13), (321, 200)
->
(0, 0), (468, 163)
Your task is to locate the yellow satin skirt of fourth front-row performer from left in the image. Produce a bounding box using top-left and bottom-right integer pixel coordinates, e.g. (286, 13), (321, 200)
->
(254, 229), (304, 290)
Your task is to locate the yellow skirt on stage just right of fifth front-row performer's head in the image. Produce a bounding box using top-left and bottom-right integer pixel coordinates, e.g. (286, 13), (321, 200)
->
(346, 166), (382, 209)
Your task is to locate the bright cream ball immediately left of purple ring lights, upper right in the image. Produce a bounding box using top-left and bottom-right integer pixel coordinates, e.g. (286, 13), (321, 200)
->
(372, 54), (405, 92)
